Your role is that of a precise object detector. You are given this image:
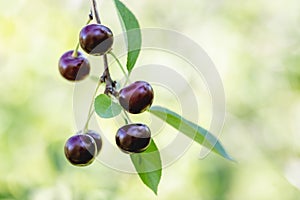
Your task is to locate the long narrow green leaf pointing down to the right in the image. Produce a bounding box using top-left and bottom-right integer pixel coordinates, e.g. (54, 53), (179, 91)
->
(149, 106), (234, 161)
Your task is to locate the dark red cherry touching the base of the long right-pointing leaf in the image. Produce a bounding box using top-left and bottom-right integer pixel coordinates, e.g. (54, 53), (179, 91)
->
(119, 81), (154, 114)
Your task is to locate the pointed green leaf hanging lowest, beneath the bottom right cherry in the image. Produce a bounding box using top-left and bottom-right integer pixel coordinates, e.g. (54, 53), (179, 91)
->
(130, 140), (162, 195)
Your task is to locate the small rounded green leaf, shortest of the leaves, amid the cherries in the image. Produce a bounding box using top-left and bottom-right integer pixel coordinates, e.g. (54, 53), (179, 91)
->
(94, 94), (122, 118)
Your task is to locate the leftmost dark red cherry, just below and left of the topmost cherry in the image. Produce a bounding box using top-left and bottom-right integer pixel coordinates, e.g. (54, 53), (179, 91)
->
(58, 50), (90, 81)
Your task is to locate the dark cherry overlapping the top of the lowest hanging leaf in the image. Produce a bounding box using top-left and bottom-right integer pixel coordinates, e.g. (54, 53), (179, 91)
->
(116, 124), (151, 153)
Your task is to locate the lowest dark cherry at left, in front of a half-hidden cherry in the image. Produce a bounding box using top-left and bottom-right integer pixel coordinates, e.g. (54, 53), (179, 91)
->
(64, 134), (97, 166)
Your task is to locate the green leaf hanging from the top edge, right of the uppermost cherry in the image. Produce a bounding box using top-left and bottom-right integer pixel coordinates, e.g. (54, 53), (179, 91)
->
(114, 0), (142, 74)
